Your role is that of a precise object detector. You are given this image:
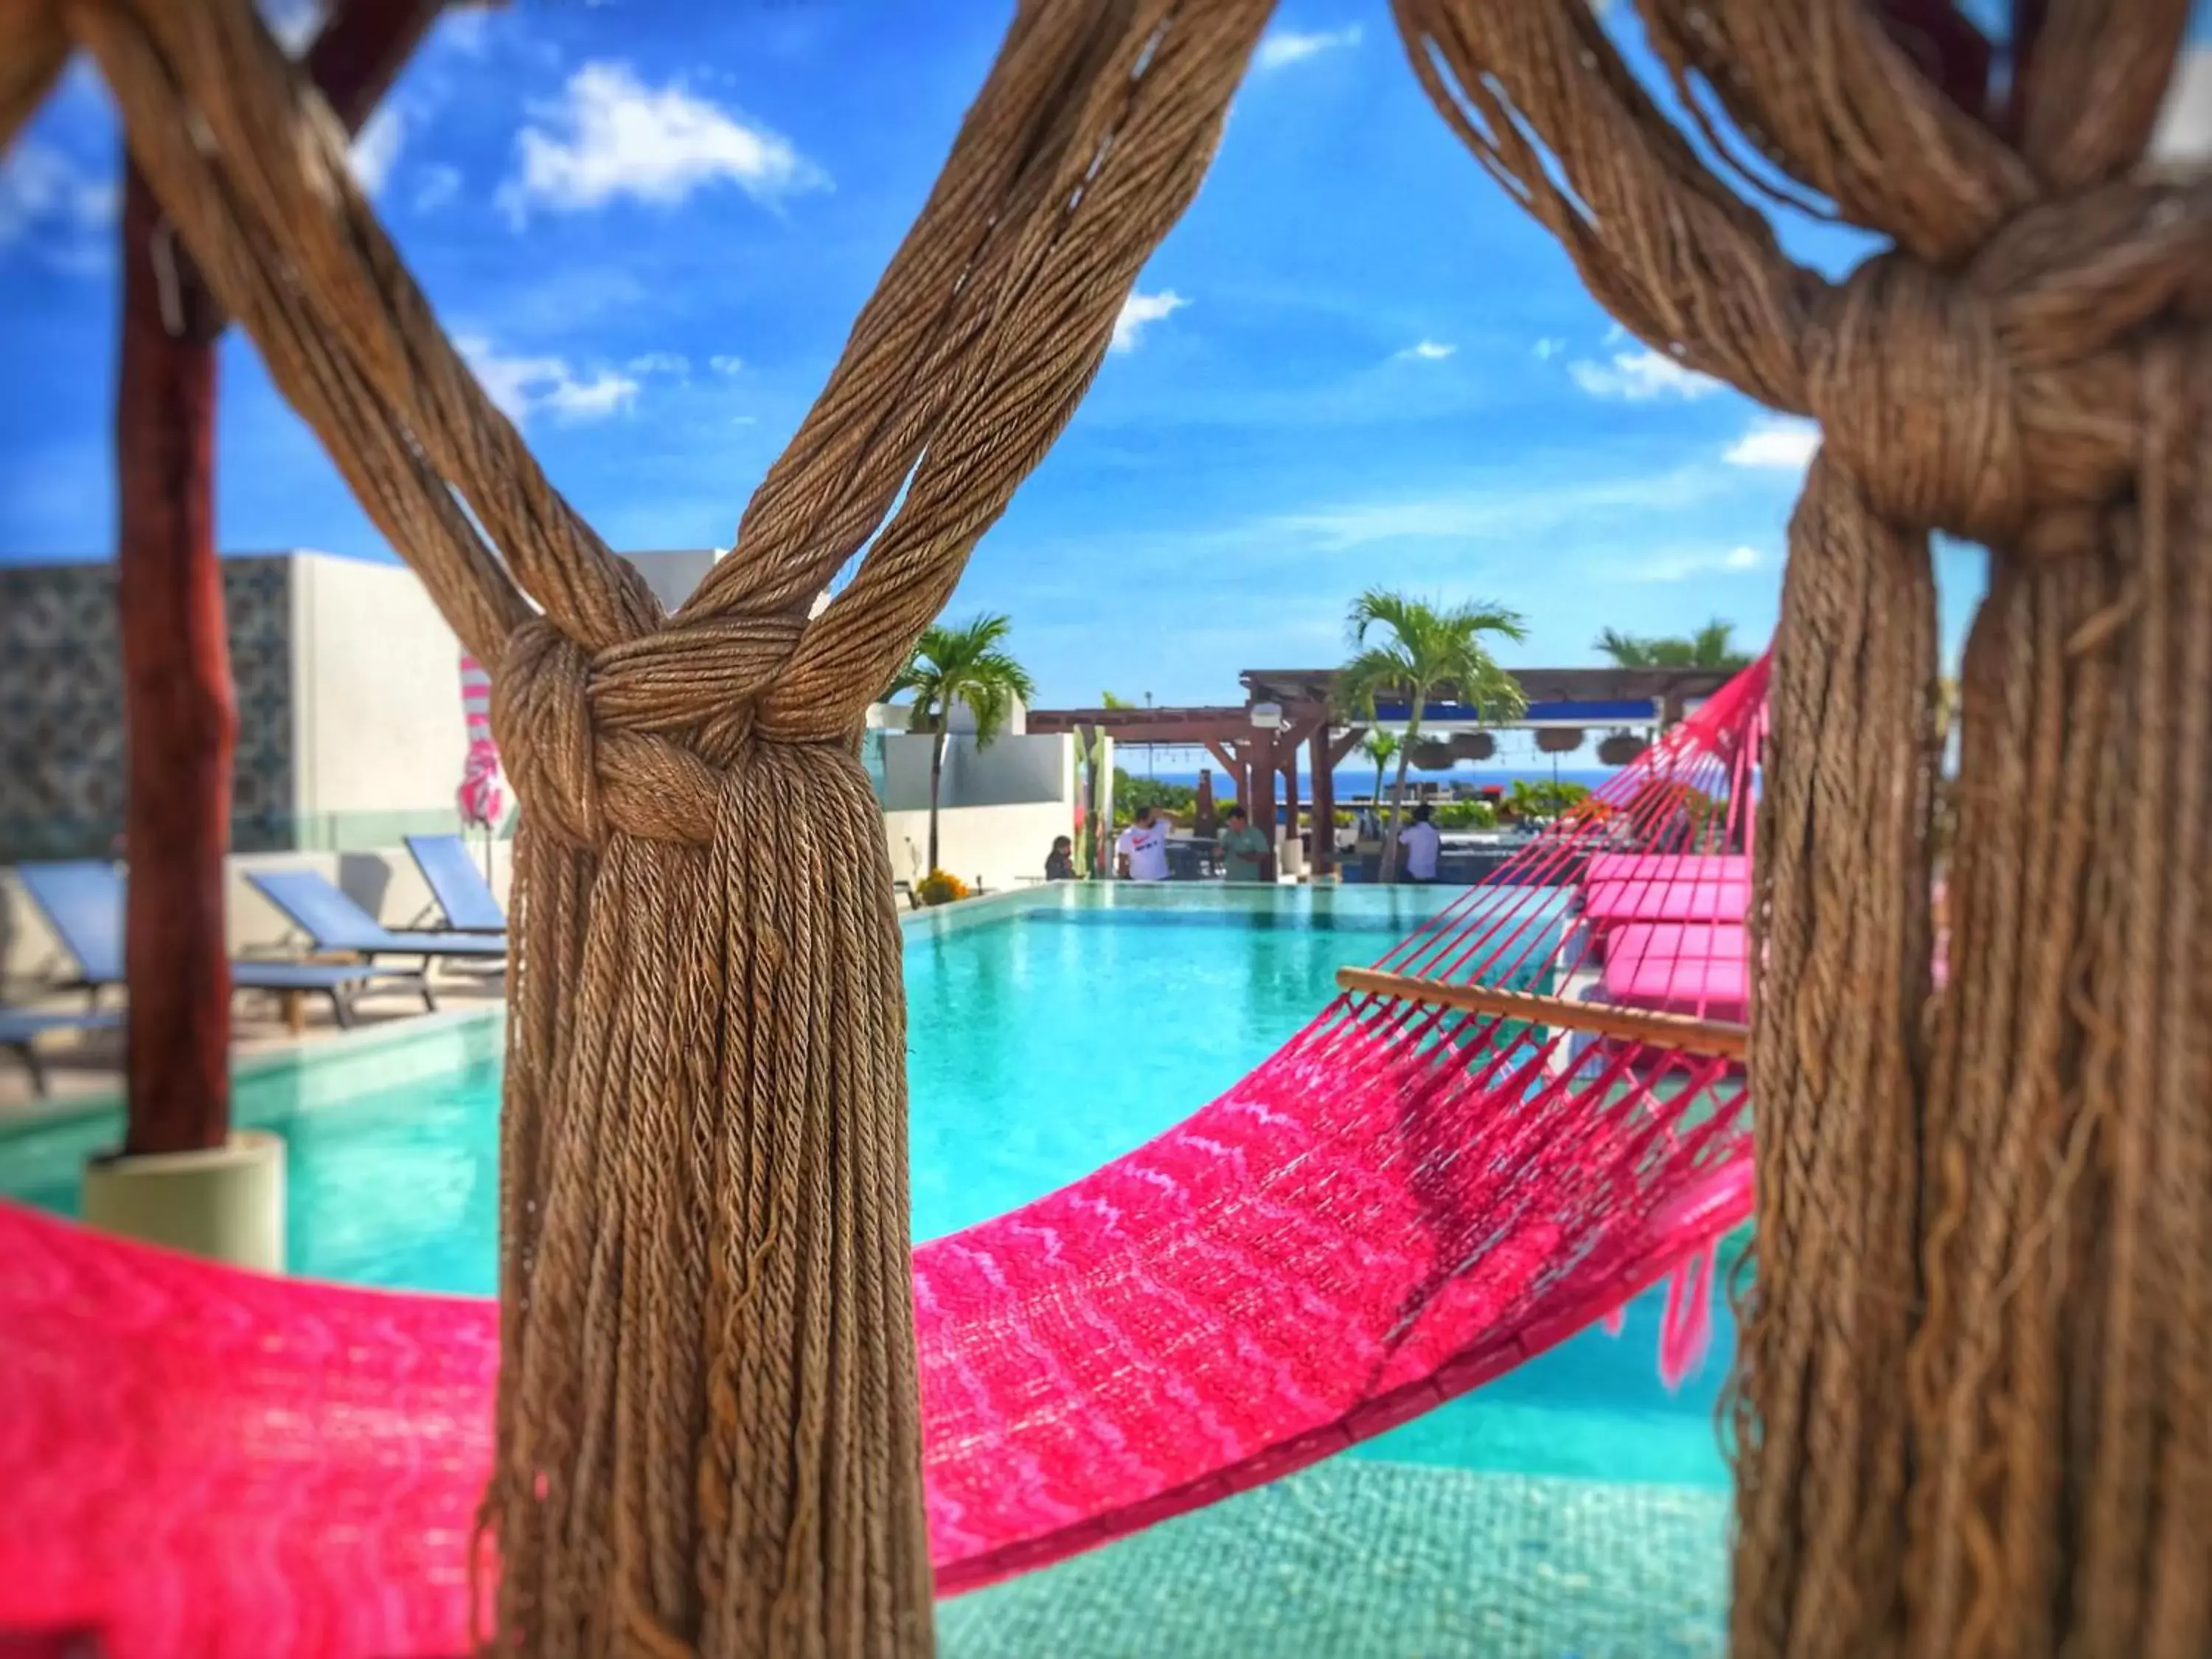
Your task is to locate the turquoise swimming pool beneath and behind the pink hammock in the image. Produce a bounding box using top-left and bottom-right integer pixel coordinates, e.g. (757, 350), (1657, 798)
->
(0, 887), (1728, 1659)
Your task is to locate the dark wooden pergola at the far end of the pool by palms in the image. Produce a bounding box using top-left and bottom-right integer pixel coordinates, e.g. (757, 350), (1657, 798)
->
(1029, 668), (1734, 880)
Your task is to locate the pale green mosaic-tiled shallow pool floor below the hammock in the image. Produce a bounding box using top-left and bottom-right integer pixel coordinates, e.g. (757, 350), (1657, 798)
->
(938, 1458), (1728, 1659)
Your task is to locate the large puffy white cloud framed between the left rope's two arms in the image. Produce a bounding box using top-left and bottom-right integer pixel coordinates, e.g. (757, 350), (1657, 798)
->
(498, 62), (830, 223)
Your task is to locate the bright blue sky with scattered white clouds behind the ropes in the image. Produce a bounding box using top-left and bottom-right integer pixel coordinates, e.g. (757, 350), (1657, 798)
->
(0, 0), (2203, 703)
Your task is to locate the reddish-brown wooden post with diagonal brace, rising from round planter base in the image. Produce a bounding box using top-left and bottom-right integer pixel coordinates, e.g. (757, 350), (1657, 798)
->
(115, 0), (440, 1155)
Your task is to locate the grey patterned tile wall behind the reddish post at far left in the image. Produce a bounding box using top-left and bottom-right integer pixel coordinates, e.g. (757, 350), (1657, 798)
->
(0, 557), (299, 863)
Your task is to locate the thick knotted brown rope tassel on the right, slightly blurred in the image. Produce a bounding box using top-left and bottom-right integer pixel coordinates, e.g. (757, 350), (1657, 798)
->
(1396, 0), (2212, 1659)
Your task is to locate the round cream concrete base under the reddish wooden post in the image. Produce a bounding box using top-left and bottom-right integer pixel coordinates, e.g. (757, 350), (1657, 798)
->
(82, 1130), (285, 1274)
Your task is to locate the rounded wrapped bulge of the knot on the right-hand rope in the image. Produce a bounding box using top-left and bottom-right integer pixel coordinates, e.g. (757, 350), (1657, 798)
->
(1805, 252), (2033, 544)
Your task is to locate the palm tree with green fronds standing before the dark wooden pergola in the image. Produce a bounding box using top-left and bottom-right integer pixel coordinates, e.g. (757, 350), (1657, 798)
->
(1336, 588), (1528, 880)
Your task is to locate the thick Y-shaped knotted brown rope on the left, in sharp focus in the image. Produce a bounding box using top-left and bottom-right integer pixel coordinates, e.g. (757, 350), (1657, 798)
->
(0, 0), (1270, 1659)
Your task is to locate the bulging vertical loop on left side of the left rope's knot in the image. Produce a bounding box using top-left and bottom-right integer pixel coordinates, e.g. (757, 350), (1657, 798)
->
(491, 617), (606, 847)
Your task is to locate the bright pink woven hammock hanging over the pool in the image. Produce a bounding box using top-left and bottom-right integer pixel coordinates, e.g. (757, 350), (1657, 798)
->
(0, 664), (1765, 1659)
